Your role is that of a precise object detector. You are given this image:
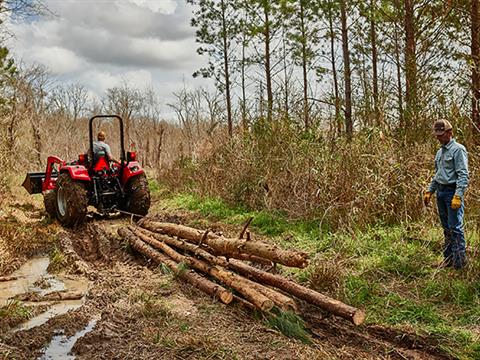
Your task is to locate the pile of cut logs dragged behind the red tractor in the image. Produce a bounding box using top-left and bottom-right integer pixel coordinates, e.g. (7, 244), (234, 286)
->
(118, 219), (365, 325)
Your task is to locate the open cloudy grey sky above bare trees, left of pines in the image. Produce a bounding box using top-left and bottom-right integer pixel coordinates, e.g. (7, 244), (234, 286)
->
(9, 0), (210, 121)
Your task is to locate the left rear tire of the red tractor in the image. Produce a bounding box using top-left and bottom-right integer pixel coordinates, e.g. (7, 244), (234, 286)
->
(55, 173), (88, 227)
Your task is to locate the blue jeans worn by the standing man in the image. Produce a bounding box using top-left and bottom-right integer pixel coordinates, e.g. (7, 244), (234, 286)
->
(437, 188), (466, 269)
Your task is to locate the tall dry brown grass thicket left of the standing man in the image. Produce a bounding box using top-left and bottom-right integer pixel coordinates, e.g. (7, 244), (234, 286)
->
(160, 121), (478, 228)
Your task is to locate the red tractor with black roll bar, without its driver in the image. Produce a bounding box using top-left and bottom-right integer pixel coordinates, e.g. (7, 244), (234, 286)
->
(23, 115), (150, 227)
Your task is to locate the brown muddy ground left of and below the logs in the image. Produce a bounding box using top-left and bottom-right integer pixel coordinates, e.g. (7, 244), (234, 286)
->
(0, 194), (450, 360)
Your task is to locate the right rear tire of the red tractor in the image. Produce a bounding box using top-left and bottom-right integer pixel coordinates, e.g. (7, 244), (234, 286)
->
(122, 174), (150, 216)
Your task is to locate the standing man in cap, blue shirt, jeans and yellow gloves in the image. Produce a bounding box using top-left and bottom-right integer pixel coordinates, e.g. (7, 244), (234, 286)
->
(423, 119), (468, 270)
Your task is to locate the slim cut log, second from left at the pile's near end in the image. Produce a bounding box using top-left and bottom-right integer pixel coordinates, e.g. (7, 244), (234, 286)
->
(124, 230), (273, 311)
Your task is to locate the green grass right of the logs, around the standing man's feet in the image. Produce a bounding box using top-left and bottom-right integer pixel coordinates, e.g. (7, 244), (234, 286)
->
(162, 194), (480, 359)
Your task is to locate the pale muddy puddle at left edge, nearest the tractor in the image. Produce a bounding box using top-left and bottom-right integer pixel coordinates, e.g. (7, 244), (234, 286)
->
(0, 257), (50, 306)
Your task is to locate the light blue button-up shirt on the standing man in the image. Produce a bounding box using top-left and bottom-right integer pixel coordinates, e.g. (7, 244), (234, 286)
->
(428, 139), (468, 197)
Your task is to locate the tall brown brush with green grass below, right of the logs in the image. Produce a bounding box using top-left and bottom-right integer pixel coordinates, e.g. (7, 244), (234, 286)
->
(158, 125), (480, 359)
